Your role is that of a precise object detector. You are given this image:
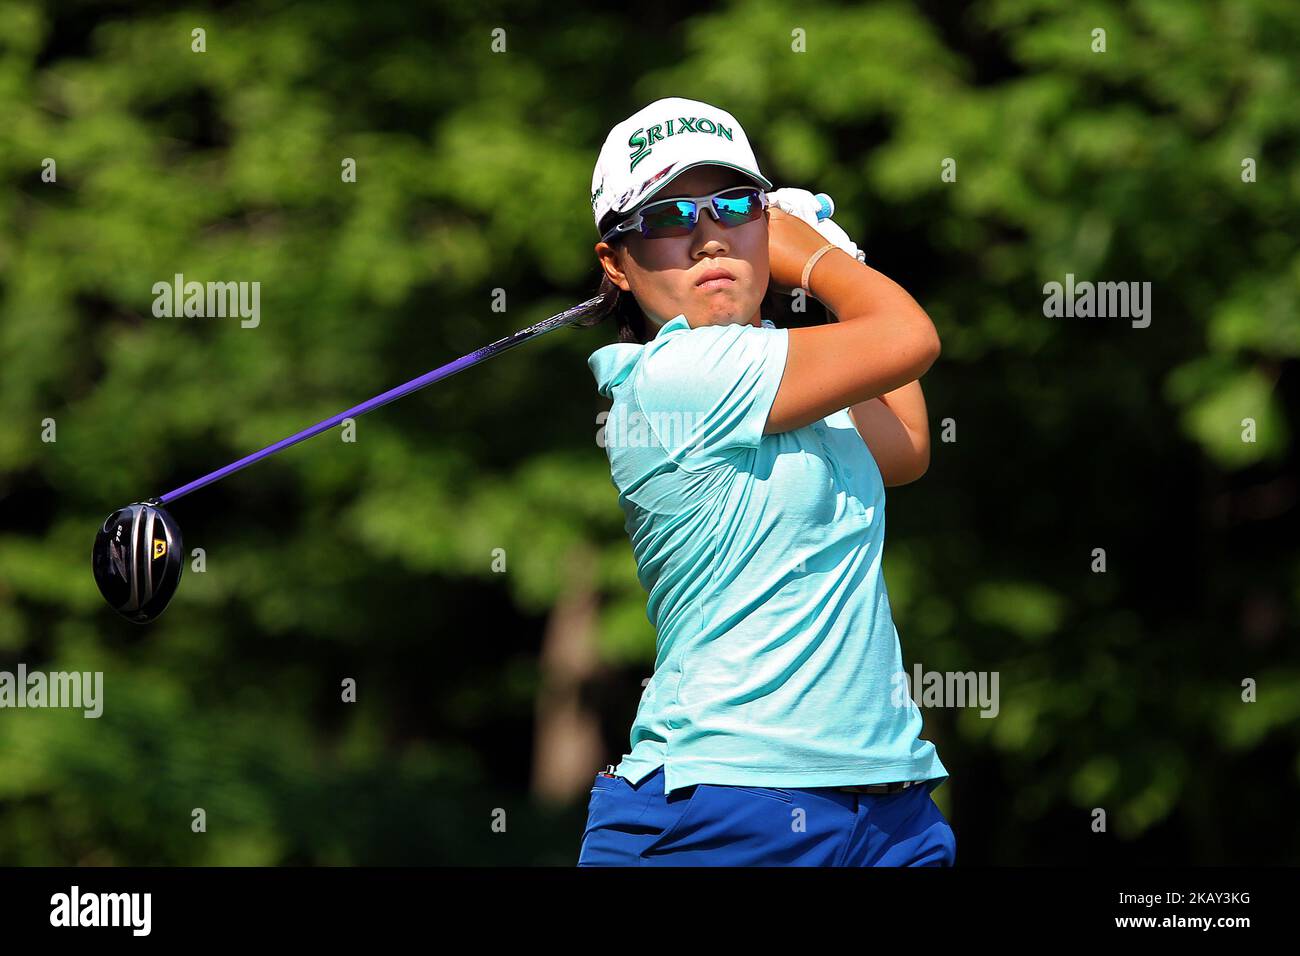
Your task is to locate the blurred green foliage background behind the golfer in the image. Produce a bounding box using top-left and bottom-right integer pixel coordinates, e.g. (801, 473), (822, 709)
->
(0, 0), (1300, 865)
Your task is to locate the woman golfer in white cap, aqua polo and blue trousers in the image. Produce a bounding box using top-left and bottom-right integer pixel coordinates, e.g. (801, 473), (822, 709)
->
(579, 98), (956, 866)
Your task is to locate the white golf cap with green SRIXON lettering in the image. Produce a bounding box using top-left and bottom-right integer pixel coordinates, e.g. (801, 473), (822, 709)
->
(592, 96), (772, 232)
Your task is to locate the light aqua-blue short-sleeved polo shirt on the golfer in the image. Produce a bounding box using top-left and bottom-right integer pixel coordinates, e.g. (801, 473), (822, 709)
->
(588, 315), (948, 792)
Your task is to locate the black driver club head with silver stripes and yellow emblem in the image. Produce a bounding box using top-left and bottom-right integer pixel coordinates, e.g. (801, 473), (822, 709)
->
(91, 501), (185, 624)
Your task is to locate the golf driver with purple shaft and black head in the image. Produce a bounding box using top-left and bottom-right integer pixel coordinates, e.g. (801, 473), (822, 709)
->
(91, 193), (835, 624)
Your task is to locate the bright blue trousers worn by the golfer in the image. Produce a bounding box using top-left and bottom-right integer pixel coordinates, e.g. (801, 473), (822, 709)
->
(577, 767), (957, 866)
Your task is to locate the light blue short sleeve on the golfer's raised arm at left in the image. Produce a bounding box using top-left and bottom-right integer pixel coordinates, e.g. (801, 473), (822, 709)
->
(637, 324), (789, 463)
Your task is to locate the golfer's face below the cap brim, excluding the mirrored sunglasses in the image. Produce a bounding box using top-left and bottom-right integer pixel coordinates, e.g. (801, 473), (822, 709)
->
(595, 165), (768, 334)
